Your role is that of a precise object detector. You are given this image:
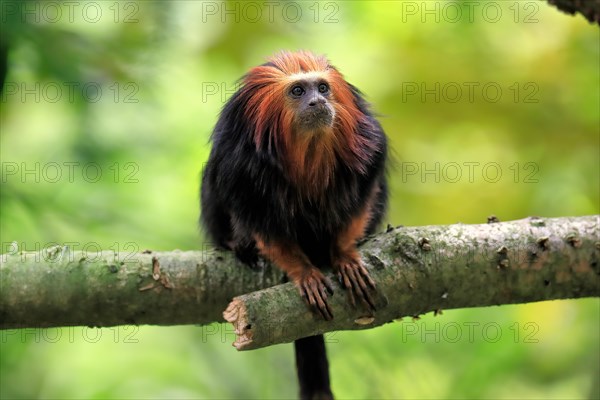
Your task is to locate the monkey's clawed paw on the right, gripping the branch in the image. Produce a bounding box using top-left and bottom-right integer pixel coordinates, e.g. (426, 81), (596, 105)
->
(334, 252), (375, 311)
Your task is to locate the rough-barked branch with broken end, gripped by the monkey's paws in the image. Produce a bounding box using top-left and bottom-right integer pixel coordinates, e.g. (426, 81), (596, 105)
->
(224, 216), (600, 350)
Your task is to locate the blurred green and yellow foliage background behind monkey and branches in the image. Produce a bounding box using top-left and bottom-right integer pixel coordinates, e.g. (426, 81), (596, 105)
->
(0, 1), (600, 399)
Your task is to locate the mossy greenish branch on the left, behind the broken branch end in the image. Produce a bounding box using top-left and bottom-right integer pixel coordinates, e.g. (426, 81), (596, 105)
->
(0, 246), (283, 329)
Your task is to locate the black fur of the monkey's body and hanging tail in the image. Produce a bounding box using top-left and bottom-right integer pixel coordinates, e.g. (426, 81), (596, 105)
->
(201, 69), (388, 399)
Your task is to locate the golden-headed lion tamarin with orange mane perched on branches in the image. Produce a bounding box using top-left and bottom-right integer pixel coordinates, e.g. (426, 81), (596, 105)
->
(201, 51), (387, 399)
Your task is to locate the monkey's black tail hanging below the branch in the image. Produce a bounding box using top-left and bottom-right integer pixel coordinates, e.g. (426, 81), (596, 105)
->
(294, 335), (333, 400)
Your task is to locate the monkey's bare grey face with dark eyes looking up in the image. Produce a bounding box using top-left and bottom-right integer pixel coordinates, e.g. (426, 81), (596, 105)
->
(287, 74), (335, 131)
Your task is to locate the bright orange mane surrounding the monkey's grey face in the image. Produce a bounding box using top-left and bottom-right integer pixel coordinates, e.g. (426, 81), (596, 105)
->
(242, 51), (371, 197)
